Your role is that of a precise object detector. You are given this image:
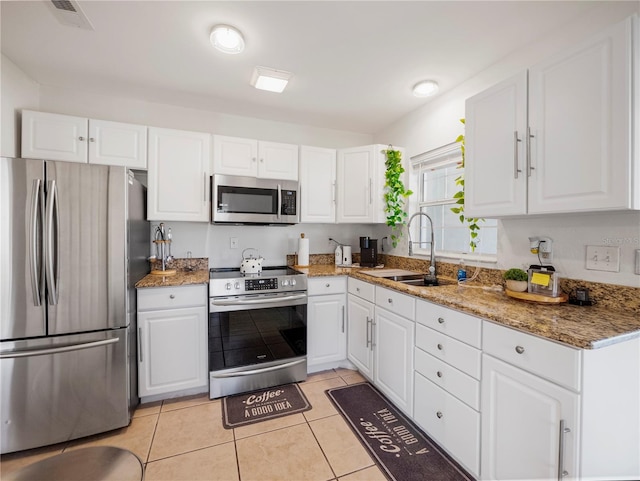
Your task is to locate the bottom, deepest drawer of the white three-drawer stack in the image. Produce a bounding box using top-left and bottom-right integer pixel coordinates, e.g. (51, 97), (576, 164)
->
(414, 373), (480, 477)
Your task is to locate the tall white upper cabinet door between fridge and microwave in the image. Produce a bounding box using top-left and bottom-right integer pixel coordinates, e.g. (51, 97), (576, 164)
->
(147, 128), (210, 222)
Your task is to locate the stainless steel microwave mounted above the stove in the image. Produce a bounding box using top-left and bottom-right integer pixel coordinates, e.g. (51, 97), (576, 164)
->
(211, 174), (300, 224)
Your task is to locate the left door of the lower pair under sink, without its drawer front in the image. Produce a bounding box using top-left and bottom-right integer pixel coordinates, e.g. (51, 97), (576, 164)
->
(347, 295), (375, 380)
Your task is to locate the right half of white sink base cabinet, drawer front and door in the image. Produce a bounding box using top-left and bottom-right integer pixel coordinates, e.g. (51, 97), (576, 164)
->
(373, 286), (415, 416)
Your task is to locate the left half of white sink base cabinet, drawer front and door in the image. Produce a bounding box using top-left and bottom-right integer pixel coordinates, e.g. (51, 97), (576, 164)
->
(347, 277), (375, 381)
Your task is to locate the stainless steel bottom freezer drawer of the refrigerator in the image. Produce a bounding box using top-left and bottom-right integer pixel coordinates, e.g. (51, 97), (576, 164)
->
(0, 329), (130, 454)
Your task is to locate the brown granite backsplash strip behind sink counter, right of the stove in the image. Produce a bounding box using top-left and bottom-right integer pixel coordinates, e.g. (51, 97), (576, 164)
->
(287, 253), (640, 313)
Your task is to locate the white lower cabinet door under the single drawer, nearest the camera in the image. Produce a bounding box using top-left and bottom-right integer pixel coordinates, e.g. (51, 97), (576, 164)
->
(481, 355), (579, 480)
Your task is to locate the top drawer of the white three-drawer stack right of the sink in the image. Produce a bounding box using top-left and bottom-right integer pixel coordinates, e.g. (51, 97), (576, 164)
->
(416, 300), (482, 349)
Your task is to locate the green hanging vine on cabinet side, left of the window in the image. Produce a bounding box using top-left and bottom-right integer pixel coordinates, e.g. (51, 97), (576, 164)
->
(382, 145), (413, 247)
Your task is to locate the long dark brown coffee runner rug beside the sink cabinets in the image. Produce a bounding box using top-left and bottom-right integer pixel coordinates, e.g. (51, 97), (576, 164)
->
(327, 383), (473, 481)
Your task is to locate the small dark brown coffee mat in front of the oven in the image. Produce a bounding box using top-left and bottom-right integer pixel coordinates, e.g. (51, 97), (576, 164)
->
(222, 384), (311, 429)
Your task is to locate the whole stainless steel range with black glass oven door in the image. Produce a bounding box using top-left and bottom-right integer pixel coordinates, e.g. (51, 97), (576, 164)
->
(209, 267), (307, 399)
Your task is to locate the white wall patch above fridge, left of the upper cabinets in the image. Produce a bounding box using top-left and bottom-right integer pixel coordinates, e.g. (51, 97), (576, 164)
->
(0, 55), (39, 157)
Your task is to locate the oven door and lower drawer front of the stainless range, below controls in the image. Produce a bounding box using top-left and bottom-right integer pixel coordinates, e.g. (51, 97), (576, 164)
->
(209, 292), (307, 399)
